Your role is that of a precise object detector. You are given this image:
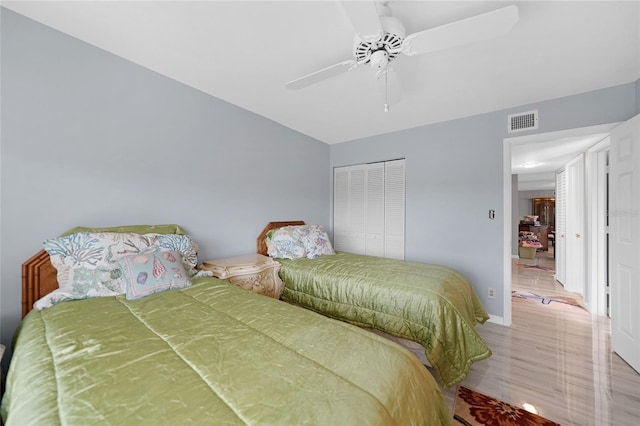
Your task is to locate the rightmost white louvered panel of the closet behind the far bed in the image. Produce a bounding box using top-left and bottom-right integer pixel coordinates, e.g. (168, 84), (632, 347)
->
(384, 160), (405, 260)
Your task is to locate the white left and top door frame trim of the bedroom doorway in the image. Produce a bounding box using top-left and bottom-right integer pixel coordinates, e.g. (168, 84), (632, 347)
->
(502, 123), (619, 326)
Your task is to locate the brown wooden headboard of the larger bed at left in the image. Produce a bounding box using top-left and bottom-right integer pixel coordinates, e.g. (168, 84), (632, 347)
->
(22, 250), (58, 318)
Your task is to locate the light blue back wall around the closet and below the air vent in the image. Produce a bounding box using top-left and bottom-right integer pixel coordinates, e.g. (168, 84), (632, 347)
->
(331, 83), (638, 317)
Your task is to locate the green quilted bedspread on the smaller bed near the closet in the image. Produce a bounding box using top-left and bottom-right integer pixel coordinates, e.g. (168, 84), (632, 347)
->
(278, 252), (491, 387)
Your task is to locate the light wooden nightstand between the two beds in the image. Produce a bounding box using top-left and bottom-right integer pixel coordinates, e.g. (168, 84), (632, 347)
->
(200, 254), (282, 299)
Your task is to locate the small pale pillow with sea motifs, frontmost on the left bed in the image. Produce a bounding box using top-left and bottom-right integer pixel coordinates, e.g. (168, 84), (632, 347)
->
(118, 250), (191, 299)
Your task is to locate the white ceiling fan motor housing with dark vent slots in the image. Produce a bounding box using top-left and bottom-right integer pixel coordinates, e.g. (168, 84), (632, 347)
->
(353, 16), (407, 69)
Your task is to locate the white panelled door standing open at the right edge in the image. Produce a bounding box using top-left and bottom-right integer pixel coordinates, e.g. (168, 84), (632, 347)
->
(609, 115), (640, 372)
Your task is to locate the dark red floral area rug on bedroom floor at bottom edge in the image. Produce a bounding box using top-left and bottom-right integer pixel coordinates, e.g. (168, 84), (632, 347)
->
(453, 386), (560, 426)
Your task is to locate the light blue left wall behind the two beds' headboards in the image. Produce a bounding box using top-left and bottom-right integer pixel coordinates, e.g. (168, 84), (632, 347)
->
(0, 9), (330, 356)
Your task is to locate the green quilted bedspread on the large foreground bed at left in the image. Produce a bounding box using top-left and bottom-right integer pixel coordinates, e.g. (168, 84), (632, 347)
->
(2, 278), (451, 426)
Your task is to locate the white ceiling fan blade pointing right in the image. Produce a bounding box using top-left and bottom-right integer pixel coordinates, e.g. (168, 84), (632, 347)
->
(403, 5), (519, 56)
